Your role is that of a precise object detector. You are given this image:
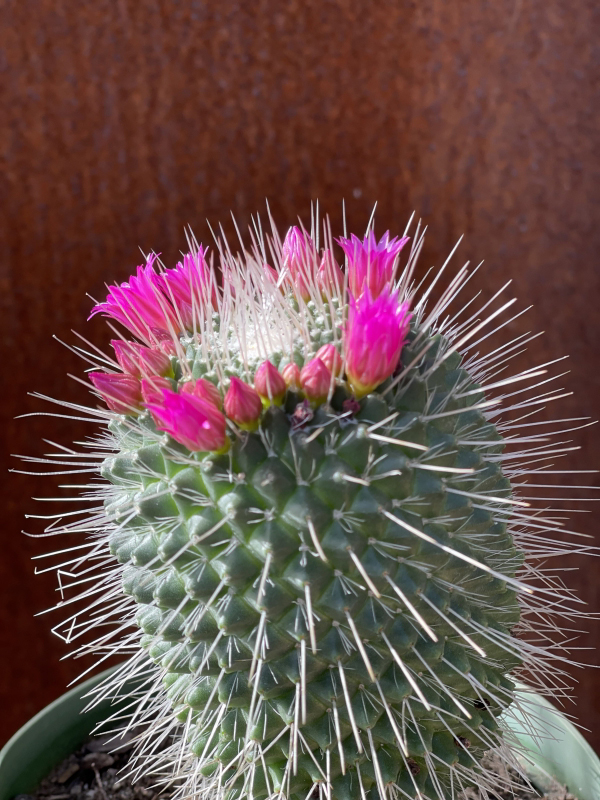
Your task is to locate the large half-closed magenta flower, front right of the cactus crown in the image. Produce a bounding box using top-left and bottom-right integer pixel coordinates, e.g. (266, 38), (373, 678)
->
(344, 287), (410, 397)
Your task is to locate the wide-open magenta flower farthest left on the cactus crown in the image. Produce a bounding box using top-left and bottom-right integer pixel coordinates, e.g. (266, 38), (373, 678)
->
(88, 255), (178, 343)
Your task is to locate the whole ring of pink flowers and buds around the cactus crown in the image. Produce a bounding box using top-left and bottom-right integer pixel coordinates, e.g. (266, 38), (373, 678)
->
(89, 227), (410, 452)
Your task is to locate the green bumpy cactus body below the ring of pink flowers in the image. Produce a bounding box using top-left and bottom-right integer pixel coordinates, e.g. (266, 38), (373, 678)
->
(103, 328), (522, 800)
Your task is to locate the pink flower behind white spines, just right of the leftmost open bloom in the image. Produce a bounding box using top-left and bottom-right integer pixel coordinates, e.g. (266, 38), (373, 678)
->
(160, 246), (218, 330)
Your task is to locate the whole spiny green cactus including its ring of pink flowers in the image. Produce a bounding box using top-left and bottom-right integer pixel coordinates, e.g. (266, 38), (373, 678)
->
(22, 212), (589, 800)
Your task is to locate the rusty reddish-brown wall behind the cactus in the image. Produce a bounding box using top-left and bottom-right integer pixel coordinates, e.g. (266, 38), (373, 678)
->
(0, 0), (600, 747)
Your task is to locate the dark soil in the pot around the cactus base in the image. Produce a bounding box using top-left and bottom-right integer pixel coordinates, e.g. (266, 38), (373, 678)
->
(15, 736), (576, 800)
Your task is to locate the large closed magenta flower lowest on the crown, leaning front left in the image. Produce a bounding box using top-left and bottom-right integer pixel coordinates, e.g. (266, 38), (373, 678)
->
(148, 389), (227, 451)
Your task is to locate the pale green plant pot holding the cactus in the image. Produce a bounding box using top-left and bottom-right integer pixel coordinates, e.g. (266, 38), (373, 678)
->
(0, 670), (600, 800)
